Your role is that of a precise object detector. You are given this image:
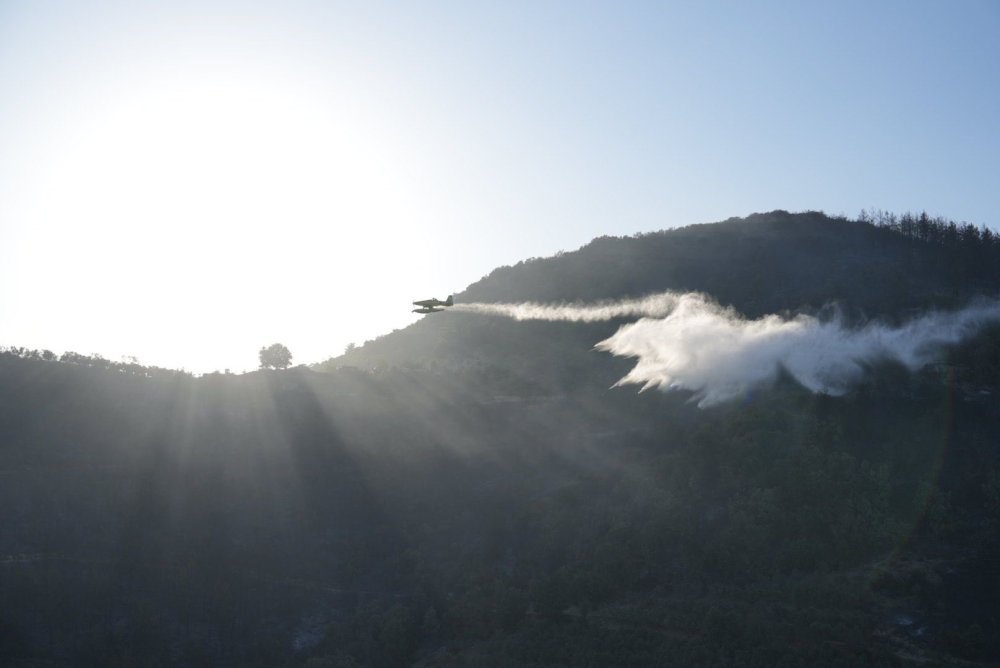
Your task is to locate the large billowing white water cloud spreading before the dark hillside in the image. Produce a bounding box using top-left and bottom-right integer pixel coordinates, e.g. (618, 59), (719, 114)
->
(596, 295), (1000, 407)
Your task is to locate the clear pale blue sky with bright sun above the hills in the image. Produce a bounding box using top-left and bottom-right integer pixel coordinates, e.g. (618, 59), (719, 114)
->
(0, 0), (1000, 373)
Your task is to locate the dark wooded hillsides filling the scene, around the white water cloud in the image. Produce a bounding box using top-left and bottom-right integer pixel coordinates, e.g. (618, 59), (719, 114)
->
(0, 212), (1000, 667)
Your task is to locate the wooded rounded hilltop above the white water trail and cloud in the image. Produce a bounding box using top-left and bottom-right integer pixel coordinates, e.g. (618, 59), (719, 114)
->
(459, 211), (1000, 316)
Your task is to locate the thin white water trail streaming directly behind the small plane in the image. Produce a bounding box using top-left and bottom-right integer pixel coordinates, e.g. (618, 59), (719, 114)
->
(449, 292), (684, 322)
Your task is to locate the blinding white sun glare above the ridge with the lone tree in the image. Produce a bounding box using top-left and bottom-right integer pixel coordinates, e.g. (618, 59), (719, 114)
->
(11, 70), (428, 371)
